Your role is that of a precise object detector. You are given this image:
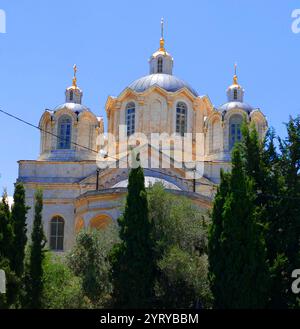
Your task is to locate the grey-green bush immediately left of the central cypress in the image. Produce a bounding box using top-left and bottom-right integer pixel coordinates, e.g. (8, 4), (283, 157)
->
(67, 224), (119, 307)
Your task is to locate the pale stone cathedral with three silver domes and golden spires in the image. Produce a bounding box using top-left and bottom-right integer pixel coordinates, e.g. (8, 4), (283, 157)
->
(18, 23), (267, 252)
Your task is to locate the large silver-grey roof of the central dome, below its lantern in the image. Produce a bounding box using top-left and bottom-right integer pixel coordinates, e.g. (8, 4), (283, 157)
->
(128, 73), (198, 97)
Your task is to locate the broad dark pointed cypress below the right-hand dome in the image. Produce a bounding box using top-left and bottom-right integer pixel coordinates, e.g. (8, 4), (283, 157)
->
(209, 146), (268, 308)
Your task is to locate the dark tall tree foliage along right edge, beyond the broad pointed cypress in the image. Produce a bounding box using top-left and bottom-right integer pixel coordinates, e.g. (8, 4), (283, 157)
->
(242, 117), (300, 308)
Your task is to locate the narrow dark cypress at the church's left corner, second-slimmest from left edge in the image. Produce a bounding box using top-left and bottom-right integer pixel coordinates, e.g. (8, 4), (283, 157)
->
(11, 183), (28, 278)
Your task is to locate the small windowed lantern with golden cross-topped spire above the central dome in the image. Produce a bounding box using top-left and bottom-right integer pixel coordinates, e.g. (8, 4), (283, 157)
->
(149, 18), (173, 75)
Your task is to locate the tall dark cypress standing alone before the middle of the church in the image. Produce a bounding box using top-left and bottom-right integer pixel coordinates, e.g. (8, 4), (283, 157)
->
(110, 167), (155, 308)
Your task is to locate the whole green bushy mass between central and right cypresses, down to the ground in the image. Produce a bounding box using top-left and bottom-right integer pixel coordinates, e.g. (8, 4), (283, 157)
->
(148, 183), (211, 308)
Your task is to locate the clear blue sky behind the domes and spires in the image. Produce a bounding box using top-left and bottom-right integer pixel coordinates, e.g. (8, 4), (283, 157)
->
(0, 0), (300, 194)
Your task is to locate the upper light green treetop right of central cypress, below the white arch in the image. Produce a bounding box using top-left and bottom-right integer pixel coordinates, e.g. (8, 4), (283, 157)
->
(148, 183), (207, 257)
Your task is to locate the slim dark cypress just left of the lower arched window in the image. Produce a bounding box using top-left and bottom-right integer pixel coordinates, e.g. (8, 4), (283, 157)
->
(25, 190), (46, 309)
